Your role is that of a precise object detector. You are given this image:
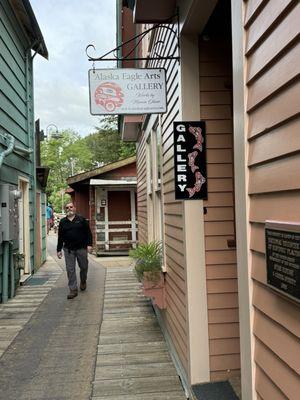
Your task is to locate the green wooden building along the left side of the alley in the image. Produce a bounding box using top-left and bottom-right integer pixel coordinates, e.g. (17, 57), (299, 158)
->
(0, 0), (48, 302)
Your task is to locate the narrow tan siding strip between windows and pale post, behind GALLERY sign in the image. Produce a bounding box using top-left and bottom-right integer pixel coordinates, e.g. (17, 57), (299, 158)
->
(161, 48), (188, 373)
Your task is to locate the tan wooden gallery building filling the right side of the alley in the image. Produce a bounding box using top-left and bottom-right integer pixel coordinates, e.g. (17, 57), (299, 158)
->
(117, 0), (300, 400)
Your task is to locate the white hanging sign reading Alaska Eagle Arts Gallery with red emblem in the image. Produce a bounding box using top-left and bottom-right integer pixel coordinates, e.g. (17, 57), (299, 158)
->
(89, 68), (167, 115)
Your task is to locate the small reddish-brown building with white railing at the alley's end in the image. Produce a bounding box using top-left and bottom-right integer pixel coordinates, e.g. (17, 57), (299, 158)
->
(67, 157), (138, 255)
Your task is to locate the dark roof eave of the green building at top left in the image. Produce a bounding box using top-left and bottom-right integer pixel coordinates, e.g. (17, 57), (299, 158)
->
(9, 0), (48, 59)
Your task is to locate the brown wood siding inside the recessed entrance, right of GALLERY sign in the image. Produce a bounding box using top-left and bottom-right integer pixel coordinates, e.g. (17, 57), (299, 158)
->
(199, 14), (240, 381)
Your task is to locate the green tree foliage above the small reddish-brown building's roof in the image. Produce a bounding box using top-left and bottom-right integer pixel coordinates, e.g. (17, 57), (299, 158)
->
(41, 117), (135, 211)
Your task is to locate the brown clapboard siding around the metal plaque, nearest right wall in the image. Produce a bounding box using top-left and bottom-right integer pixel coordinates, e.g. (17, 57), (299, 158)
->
(245, 0), (300, 400)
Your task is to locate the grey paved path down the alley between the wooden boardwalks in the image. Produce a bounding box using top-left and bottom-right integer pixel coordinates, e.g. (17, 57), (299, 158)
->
(0, 236), (105, 400)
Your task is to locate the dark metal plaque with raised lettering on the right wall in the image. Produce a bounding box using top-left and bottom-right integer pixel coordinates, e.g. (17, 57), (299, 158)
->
(265, 221), (300, 302)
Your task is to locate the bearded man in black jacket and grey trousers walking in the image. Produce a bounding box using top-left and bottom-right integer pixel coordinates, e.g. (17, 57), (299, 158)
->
(57, 203), (92, 299)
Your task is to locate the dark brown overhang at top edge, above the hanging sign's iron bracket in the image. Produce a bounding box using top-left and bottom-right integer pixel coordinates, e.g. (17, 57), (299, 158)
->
(133, 0), (176, 24)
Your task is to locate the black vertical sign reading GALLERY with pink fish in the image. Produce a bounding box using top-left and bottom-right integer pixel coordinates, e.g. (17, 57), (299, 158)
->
(173, 121), (207, 200)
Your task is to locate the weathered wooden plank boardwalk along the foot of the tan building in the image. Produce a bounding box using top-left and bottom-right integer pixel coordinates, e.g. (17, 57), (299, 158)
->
(92, 267), (186, 400)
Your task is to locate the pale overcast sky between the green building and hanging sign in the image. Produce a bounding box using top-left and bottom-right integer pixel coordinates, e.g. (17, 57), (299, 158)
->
(31, 0), (116, 136)
